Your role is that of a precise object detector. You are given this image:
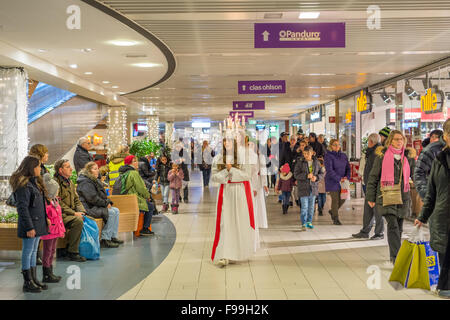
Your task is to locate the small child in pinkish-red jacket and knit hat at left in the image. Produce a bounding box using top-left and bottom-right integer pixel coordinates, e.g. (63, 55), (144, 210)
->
(41, 173), (66, 283)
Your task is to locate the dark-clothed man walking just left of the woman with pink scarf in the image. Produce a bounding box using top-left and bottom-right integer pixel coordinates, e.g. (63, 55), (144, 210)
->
(352, 133), (384, 240)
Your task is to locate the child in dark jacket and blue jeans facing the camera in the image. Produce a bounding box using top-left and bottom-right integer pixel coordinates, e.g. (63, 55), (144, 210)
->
(294, 146), (323, 231)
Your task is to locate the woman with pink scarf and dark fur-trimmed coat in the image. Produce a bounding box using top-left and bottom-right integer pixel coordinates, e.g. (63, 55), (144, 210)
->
(366, 130), (416, 264)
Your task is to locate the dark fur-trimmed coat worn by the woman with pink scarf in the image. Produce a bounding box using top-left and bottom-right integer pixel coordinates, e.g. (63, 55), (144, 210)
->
(366, 146), (416, 218)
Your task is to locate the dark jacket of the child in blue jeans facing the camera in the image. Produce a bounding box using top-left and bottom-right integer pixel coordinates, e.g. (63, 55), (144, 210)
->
(294, 158), (323, 198)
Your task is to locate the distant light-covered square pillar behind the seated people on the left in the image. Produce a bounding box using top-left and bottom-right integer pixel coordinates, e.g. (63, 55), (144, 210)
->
(107, 107), (127, 155)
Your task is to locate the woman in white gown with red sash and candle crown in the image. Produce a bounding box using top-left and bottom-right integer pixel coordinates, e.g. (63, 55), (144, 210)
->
(211, 139), (255, 267)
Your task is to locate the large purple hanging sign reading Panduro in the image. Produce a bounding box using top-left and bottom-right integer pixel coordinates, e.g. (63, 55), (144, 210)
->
(254, 22), (345, 48)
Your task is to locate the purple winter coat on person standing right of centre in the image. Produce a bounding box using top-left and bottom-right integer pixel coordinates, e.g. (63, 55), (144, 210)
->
(324, 151), (350, 192)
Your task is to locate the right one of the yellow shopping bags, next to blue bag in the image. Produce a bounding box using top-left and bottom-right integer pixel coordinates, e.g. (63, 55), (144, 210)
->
(406, 244), (430, 290)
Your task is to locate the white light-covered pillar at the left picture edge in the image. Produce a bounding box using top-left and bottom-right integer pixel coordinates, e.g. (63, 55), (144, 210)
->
(0, 67), (28, 199)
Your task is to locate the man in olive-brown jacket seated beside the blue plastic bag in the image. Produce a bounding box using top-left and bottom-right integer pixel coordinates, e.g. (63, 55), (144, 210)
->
(55, 159), (86, 262)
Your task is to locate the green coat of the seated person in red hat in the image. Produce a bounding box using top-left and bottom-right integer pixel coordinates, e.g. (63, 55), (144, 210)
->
(119, 165), (150, 211)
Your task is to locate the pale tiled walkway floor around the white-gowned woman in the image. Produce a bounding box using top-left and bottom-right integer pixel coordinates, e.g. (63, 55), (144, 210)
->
(120, 172), (439, 300)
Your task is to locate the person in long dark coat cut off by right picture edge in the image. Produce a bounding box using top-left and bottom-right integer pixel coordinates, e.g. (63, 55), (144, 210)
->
(414, 119), (450, 298)
